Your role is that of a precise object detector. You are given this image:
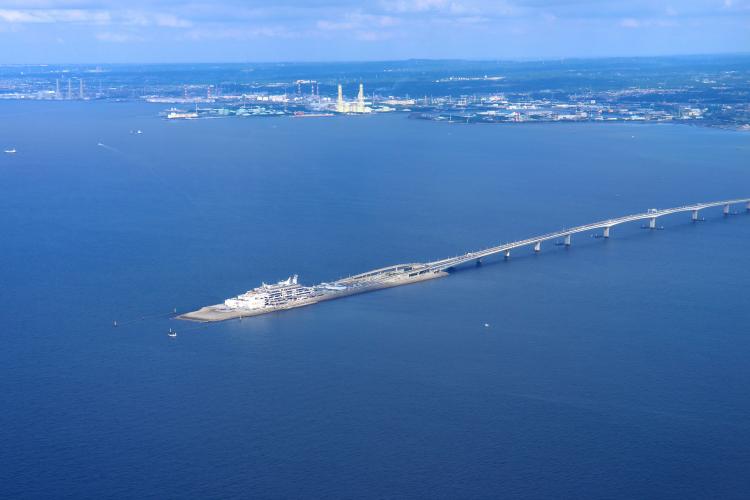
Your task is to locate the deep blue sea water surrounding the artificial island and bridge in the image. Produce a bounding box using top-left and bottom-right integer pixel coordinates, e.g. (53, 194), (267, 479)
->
(0, 103), (750, 499)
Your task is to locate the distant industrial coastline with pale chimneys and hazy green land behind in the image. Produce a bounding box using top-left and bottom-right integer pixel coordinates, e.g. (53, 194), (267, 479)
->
(0, 55), (750, 130)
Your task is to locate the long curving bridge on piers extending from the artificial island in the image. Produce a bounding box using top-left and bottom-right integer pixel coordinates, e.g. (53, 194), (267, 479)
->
(419, 198), (750, 274)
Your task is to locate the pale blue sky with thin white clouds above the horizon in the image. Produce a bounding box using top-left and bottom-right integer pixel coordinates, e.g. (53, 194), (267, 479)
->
(0, 0), (750, 64)
